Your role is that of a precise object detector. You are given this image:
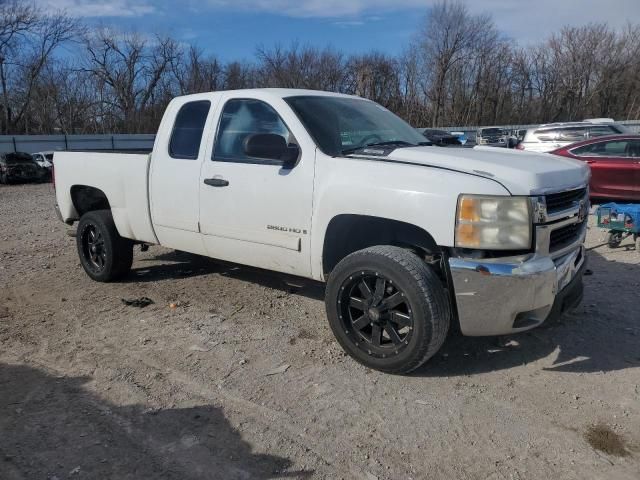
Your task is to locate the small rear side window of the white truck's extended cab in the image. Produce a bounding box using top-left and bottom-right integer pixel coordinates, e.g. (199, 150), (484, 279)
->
(169, 100), (211, 160)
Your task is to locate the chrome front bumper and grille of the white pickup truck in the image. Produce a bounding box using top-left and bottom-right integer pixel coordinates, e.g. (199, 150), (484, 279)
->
(449, 186), (589, 336)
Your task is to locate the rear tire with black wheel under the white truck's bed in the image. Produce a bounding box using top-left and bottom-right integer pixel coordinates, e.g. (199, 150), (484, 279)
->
(76, 210), (133, 282)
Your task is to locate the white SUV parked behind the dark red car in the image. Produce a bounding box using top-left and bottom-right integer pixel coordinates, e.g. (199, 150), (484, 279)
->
(516, 119), (630, 152)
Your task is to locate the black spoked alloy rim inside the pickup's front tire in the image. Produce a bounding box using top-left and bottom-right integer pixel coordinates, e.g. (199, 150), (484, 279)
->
(338, 271), (413, 358)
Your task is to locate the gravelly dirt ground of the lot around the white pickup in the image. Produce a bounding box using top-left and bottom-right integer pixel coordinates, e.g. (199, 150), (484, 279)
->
(0, 185), (640, 480)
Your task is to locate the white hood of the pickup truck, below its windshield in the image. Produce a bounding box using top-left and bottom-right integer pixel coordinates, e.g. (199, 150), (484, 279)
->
(368, 147), (589, 195)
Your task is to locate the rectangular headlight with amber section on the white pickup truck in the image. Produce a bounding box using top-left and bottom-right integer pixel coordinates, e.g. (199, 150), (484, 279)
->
(455, 195), (531, 250)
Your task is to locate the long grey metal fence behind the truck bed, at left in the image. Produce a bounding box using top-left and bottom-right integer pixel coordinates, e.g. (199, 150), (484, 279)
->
(0, 134), (156, 153)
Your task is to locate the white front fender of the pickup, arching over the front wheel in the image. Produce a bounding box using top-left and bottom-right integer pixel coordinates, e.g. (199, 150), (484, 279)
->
(311, 153), (509, 280)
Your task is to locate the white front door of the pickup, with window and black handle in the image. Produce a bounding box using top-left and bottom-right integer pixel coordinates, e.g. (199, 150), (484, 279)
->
(200, 96), (315, 275)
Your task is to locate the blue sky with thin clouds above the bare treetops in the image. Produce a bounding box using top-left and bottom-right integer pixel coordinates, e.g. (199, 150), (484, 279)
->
(36, 0), (640, 59)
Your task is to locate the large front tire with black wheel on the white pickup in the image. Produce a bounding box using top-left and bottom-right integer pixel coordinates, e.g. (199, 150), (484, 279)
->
(325, 246), (451, 373)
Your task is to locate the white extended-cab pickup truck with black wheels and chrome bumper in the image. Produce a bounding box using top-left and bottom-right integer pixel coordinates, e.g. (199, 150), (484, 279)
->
(55, 89), (589, 373)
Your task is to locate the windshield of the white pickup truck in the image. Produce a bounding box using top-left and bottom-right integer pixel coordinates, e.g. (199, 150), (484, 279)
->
(285, 96), (429, 157)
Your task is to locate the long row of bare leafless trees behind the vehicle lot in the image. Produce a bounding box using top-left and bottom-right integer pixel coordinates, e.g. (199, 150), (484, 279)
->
(0, 0), (640, 133)
